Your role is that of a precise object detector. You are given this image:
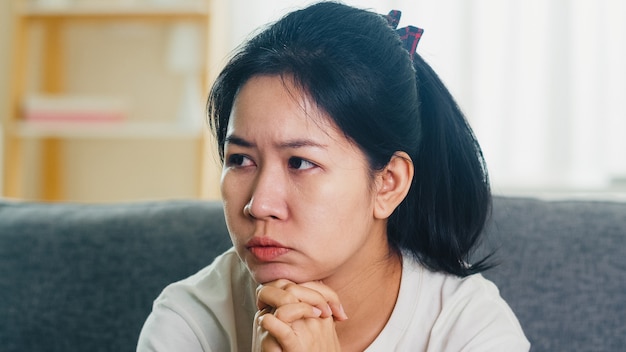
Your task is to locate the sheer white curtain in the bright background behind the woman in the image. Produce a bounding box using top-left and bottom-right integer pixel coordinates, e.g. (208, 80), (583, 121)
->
(222, 0), (626, 193)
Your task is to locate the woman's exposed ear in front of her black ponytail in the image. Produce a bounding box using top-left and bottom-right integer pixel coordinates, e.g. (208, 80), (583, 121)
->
(374, 152), (414, 219)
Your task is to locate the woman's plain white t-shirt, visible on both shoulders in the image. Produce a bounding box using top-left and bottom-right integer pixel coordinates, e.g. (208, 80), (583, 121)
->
(137, 249), (530, 352)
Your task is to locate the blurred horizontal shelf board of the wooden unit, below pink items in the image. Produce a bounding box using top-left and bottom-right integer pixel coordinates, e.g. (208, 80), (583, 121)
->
(16, 121), (202, 139)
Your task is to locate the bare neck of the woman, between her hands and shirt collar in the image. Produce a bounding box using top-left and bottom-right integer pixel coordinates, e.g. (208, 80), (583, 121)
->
(325, 246), (402, 351)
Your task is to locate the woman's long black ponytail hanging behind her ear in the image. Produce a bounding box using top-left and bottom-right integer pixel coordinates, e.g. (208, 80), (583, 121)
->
(389, 55), (491, 276)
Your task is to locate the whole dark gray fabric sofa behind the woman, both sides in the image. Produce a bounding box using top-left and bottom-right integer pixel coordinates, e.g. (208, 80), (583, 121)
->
(0, 197), (626, 352)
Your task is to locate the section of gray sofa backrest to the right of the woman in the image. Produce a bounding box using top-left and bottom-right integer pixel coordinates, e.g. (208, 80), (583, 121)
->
(485, 197), (626, 351)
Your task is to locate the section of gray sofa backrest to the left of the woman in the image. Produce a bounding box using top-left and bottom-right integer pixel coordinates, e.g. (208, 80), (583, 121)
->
(0, 201), (231, 351)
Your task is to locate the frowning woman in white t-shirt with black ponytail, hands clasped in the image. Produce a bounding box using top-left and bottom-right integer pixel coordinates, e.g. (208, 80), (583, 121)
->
(138, 2), (529, 351)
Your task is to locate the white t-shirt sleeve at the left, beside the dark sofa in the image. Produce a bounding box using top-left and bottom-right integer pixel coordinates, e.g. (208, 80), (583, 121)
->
(137, 306), (205, 352)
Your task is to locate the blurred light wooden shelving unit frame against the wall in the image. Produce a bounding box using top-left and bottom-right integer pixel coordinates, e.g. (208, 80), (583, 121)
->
(2, 0), (216, 201)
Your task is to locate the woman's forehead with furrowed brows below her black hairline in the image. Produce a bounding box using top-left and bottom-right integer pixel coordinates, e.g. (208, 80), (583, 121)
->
(225, 76), (370, 172)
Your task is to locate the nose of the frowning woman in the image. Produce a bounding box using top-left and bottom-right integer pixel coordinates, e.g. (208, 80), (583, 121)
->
(243, 165), (288, 220)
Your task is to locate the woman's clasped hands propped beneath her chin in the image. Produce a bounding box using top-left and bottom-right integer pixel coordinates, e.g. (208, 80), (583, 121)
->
(253, 280), (348, 351)
